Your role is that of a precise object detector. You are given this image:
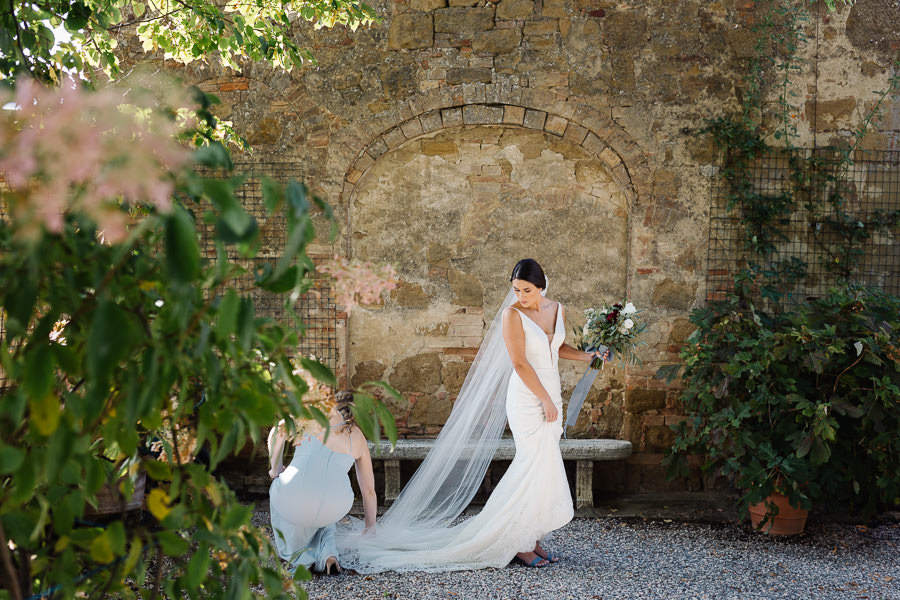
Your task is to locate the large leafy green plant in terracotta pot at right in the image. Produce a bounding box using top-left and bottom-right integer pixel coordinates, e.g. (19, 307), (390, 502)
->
(658, 281), (900, 533)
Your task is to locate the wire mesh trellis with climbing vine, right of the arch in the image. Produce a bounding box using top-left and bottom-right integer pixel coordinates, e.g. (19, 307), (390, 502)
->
(706, 150), (900, 306)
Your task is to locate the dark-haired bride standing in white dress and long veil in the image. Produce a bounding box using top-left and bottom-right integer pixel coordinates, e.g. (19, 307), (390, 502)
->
(341, 259), (609, 572)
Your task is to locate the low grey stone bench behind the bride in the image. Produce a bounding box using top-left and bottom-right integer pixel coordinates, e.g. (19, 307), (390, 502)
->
(369, 438), (631, 508)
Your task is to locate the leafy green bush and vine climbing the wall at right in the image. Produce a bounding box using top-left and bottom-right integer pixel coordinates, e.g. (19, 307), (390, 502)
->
(657, 1), (900, 515)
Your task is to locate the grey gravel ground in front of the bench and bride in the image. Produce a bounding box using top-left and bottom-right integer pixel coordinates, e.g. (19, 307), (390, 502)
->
(248, 505), (900, 600)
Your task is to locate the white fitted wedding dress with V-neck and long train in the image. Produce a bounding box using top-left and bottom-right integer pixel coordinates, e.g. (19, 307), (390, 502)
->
(341, 306), (574, 572)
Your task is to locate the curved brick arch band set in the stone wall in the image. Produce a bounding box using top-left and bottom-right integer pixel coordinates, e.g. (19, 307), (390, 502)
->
(339, 95), (650, 211)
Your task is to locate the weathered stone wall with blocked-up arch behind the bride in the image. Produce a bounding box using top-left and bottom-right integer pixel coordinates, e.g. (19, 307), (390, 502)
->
(137, 0), (900, 491)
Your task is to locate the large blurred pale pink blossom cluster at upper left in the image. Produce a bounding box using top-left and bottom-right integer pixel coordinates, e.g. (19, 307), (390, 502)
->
(0, 79), (189, 243)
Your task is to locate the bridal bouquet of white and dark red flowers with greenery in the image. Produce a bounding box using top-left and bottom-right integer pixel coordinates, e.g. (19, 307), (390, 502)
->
(575, 300), (647, 369)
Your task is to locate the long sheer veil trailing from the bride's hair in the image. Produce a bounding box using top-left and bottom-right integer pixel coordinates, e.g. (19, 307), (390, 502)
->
(339, 288), (515, 572)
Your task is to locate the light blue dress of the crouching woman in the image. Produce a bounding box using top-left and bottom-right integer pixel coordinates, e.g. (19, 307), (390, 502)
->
(269, 438), (355, 571)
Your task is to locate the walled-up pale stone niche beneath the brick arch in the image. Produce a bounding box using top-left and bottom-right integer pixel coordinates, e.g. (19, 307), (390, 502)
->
(347, 123), (630, 433)
